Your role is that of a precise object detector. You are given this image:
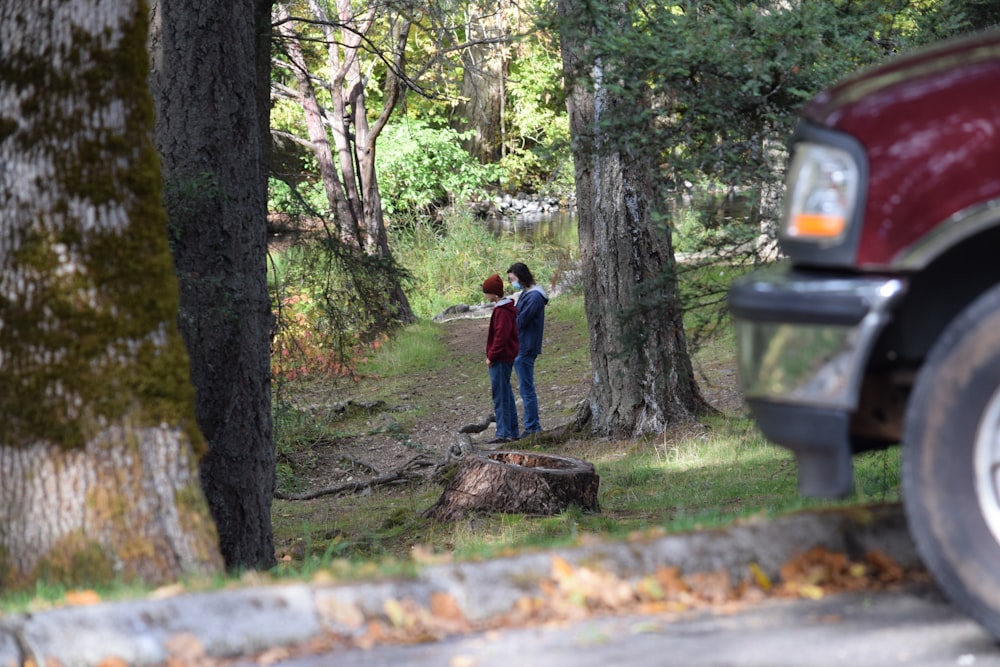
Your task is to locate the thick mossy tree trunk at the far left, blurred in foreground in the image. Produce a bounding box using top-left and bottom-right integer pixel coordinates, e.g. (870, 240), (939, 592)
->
(0, 0), (222, 589)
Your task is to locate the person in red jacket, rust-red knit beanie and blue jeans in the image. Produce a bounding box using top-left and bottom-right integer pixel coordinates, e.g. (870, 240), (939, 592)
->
(483, 273), (520, 445)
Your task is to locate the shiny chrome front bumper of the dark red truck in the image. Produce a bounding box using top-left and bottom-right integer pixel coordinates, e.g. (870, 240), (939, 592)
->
(729, 271), (906, 497)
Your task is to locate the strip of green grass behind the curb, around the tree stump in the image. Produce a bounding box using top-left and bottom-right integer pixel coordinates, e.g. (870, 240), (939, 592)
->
(275, 417), (900, 567)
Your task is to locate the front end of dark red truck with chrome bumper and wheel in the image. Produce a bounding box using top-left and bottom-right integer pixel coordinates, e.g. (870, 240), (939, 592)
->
(729, 32), (1000, 638)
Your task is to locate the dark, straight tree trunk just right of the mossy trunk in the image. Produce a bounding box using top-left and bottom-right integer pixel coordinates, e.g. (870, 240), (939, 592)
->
(146, 0), (275, 568)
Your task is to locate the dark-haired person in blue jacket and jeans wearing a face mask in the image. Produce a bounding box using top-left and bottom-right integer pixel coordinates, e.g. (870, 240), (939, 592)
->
(507, 262), (549, 436)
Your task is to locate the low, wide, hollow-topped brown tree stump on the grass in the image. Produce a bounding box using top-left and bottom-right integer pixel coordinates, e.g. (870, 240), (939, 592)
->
(423, 451), (601, 521)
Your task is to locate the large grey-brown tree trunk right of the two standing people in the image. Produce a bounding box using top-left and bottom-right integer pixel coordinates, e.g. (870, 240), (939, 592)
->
(559, 0), (708, 437)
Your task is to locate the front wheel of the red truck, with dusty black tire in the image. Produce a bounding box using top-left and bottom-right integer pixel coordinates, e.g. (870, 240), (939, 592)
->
(902, 287), (1000, 638)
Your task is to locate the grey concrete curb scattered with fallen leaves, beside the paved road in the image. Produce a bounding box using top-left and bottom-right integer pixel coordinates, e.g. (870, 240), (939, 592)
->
(0, 505), (968, 667)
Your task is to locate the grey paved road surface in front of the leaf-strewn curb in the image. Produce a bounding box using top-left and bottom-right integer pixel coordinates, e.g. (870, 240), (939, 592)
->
(275, 586), (1000, 667)
